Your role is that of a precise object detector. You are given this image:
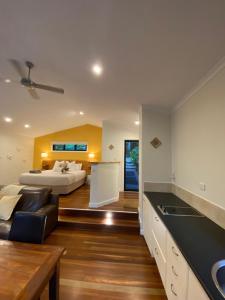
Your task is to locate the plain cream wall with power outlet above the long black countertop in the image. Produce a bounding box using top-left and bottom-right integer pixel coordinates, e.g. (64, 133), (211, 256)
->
(172, 68), (225, 207)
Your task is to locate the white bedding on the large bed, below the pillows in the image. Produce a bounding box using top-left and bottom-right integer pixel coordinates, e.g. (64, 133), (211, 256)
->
(19, 170), (86, 186)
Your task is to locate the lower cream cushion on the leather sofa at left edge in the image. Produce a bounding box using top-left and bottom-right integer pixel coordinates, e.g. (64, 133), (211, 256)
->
(0, 195), (22, 221)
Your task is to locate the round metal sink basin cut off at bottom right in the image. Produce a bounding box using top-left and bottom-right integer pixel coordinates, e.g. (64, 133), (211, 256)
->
(212, 259), (225, 299)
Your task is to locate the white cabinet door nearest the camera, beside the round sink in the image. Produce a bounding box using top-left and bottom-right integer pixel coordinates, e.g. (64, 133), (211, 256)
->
(187, 269), (209, 300)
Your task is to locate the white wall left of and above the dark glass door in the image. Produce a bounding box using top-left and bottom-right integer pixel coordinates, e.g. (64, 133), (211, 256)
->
(102, 121), (139, 191)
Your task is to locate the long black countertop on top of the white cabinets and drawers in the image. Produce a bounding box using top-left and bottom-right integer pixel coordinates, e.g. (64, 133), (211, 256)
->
(145, 192), (225, 300)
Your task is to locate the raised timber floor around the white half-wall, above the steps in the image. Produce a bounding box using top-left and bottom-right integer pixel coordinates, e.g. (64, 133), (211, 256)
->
(59, 185), (138, 212)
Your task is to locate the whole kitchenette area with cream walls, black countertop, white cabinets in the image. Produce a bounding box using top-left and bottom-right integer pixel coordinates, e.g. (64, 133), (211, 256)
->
(139, 66), (225, 300)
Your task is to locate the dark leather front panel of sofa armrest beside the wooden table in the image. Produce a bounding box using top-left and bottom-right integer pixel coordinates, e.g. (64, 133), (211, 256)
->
(9, 211), (47, 244)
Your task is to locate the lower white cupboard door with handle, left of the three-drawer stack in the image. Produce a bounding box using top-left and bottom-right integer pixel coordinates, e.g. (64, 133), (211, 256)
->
(152, 232), (166, 286)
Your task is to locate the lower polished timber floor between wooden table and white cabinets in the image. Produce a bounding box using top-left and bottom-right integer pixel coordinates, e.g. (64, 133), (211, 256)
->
(41, 225), (167, 300)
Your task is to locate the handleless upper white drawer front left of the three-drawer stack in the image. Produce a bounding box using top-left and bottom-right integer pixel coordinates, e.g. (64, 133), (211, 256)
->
(153, 210), (167, 257)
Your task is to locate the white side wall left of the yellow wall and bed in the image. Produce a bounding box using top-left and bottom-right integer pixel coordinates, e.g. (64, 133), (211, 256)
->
(0, 133), (34, 185)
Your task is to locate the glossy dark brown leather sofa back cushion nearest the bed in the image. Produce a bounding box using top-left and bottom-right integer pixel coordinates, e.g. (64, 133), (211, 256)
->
(15, 186), (51, 212)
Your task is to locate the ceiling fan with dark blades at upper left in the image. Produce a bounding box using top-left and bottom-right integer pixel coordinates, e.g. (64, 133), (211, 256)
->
(10, 59), (64, 99)
